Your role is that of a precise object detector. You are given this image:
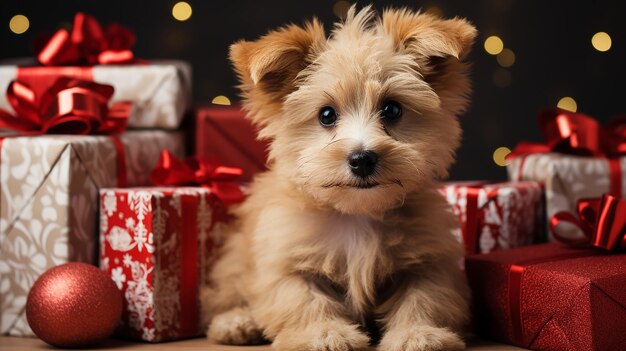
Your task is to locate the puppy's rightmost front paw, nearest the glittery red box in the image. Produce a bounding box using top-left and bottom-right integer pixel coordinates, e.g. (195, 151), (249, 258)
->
(378, 326), (465, 351)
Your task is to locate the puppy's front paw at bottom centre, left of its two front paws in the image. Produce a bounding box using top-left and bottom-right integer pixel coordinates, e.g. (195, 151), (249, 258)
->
(273, 321), (369, 351)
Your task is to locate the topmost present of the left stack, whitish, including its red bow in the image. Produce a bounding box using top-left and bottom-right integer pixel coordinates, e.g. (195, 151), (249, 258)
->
(0, 13), (191, 129)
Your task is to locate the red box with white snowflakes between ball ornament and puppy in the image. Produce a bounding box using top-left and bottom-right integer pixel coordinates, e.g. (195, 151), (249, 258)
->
(100, 187), (228, 342)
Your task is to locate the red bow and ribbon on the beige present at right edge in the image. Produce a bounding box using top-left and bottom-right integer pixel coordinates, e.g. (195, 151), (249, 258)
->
(507, 108), (626, 195)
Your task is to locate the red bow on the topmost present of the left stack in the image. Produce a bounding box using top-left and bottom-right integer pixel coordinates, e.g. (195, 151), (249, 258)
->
(38, 12), (135, 66)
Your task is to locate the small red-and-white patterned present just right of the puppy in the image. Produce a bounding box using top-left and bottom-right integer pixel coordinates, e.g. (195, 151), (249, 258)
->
(440, 182), (545, 255)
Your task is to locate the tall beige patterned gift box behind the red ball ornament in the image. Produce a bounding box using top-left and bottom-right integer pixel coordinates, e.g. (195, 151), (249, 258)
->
(0, 131), (184, 335)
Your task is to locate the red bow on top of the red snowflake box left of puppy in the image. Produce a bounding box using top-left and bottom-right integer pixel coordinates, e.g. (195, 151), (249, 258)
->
(151, 150), (244, 205)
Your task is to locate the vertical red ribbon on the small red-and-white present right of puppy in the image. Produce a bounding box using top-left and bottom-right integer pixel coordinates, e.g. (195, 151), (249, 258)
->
(461, 186), (498, 255)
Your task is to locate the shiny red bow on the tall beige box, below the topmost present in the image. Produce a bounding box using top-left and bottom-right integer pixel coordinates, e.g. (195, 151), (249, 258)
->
(0, 77), (131, 135)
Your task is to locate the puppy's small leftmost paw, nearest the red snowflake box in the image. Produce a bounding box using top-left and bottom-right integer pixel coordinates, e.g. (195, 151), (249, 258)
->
(207, 308), (265, 345)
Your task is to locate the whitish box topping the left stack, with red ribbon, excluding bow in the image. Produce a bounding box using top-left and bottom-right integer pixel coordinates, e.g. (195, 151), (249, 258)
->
(0, 60), (191, 129)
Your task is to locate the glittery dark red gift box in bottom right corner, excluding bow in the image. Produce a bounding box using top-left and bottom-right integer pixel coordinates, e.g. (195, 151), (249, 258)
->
(465, 243), (626, 351)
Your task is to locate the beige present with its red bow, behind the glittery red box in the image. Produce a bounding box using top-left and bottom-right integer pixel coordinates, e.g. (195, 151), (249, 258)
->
(507, 109), (626, 240)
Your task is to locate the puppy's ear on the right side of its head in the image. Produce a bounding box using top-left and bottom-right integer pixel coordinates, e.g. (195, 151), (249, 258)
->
(380, 9), (476, 86)
